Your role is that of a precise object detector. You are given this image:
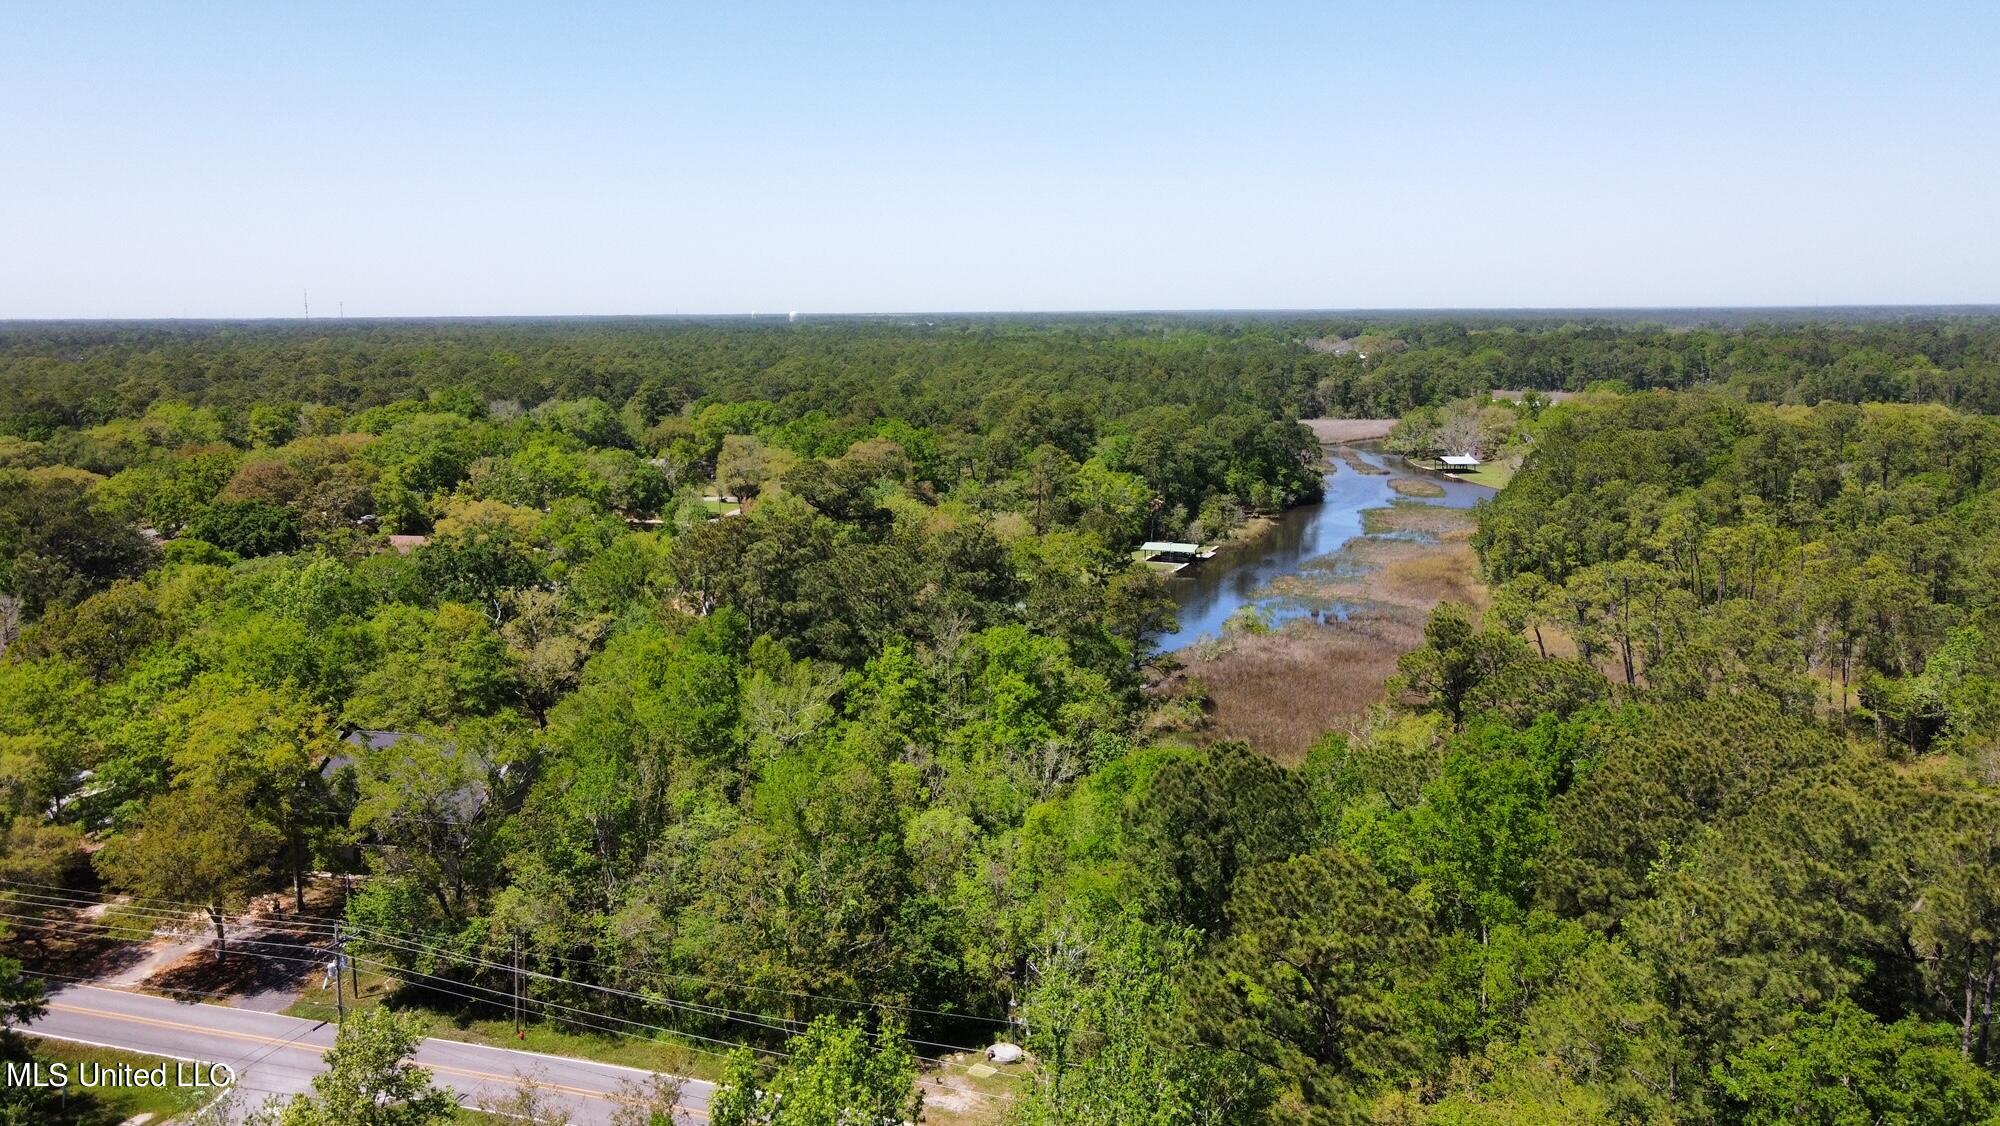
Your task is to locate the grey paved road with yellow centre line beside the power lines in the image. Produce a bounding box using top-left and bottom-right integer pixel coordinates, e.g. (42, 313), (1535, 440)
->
(22, 986), (714, 1122)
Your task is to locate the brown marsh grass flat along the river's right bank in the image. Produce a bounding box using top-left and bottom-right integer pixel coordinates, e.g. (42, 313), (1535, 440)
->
(1162, 504), (1486, 764)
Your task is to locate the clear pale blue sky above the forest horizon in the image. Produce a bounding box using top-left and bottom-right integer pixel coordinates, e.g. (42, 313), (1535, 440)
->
(0, 0), (2000, 318)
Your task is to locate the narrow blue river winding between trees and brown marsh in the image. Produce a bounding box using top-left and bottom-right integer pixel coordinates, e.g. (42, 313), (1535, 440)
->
(1160, 444), (1494, 652)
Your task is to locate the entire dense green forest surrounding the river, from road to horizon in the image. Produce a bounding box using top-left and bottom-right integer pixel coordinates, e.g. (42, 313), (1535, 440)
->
(0, 318), (2000, 1126)
